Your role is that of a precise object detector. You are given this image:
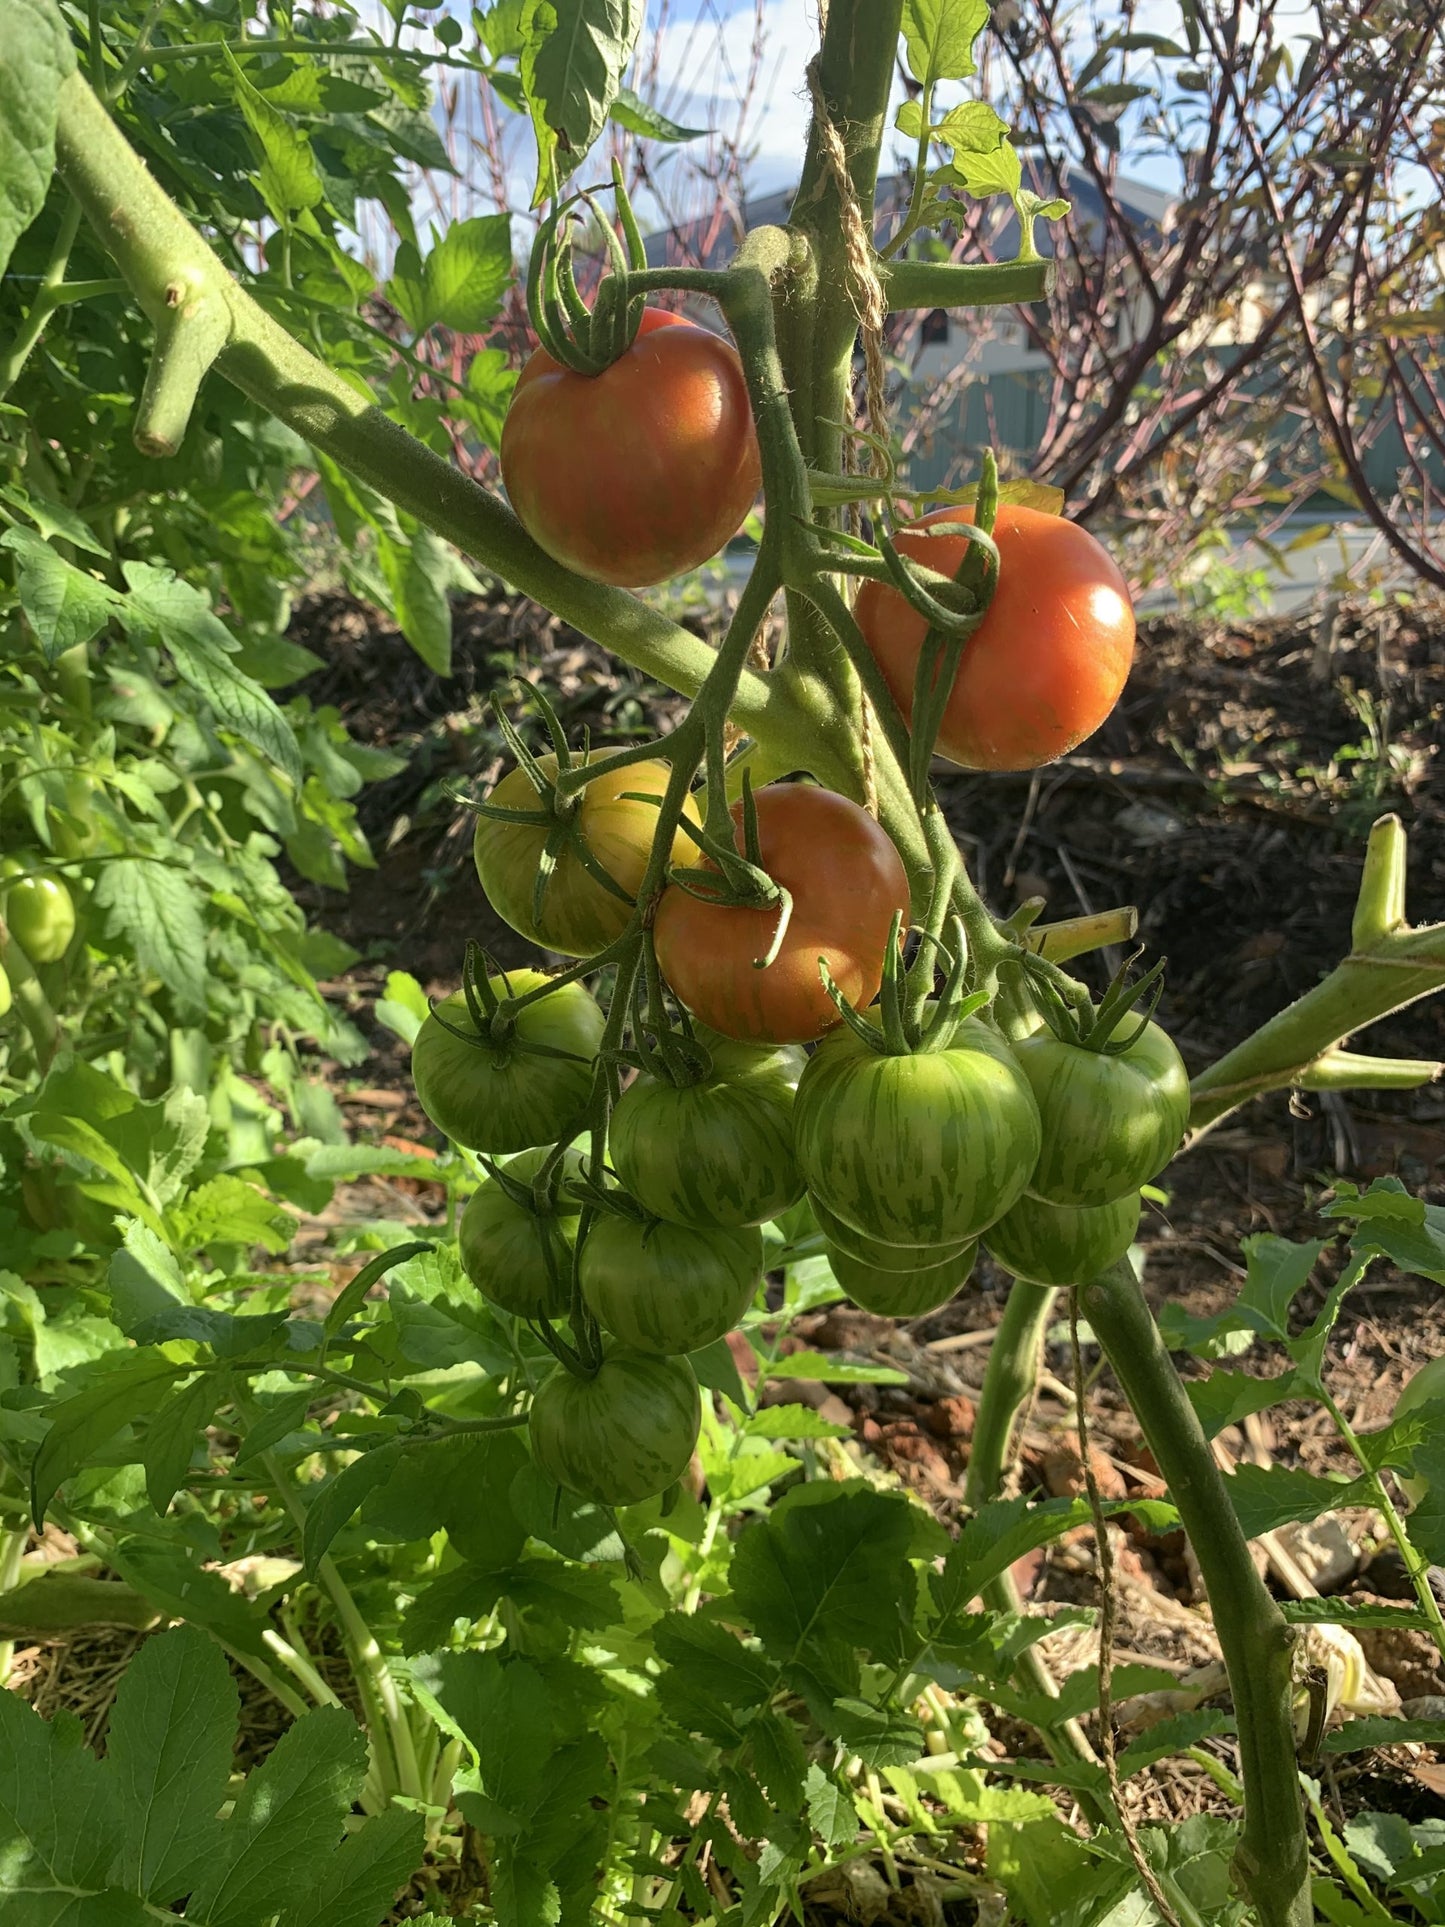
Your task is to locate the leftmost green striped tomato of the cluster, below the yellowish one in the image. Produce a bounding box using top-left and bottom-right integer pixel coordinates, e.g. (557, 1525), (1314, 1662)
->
(412, 969), (605, 1154)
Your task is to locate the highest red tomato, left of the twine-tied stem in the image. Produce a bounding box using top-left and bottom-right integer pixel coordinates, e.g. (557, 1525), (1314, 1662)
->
(501, 308), (761, 590)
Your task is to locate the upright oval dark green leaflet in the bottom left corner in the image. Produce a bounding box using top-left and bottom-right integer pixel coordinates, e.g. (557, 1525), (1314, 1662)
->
(106, 1626), (241, 1906)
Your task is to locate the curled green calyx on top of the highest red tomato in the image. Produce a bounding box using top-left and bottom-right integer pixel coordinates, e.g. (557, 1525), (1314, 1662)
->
(526, 160), (647, 376)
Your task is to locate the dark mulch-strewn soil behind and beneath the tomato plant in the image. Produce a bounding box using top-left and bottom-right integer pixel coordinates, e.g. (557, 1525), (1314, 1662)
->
(11, 581), (1445, 1921)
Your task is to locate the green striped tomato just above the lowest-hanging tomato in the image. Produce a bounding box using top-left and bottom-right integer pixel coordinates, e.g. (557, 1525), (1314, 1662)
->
(578, 1216), (763, 1357)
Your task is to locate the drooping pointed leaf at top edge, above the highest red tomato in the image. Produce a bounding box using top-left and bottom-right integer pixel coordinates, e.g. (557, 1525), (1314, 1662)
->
(520, 0), (644, 208)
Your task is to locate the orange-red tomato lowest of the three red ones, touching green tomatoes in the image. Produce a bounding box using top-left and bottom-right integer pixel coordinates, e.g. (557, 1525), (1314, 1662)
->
(653, 782), (907, 1044)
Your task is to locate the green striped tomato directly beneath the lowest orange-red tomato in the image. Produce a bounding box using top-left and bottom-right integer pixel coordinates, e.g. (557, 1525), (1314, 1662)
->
(607, 1035), (807, 1226)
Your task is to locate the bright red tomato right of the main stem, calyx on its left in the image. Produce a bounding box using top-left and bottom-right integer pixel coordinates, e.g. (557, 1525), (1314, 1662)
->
(854, 503), (1135, 769)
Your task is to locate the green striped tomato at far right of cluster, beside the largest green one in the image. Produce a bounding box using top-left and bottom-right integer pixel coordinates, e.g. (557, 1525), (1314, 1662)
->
(1013, 1017), (1189, 1204)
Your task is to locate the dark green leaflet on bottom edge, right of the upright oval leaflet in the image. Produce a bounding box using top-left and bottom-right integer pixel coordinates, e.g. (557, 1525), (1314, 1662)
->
(187, 1705), (366, 1927)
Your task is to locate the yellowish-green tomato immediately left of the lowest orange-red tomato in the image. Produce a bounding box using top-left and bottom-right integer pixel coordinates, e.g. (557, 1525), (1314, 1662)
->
(472, 753), (697, 958)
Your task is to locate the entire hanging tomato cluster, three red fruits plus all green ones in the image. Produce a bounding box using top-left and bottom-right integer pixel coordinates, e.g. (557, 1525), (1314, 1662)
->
(412, 310), (1156, 1505)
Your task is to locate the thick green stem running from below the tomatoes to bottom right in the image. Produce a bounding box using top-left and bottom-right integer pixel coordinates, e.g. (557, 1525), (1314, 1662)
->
(1083, 1262), (1314, 1927)
